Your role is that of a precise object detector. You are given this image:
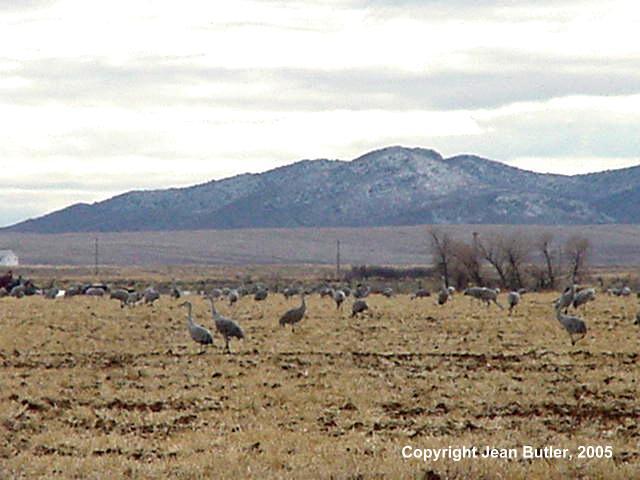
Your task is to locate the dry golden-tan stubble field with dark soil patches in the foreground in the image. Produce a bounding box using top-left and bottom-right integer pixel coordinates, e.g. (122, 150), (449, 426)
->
(0, 286), (640, 480)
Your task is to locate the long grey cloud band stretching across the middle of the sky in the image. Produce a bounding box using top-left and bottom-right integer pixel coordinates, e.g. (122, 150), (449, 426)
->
(5, 50), (640, 111)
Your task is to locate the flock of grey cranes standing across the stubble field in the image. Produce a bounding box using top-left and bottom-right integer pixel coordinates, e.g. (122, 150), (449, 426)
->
(0, 266), (640, 353)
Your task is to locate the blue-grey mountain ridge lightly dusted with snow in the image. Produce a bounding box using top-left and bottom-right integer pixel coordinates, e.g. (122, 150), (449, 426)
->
(1, 147), (640, 233)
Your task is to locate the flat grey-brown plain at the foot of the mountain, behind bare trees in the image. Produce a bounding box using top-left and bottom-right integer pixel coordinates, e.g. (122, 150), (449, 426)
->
(0, 225), (640, 267)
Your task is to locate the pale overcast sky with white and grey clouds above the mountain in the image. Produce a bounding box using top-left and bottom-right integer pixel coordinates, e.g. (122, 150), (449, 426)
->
(0, 0), (640, 225)
